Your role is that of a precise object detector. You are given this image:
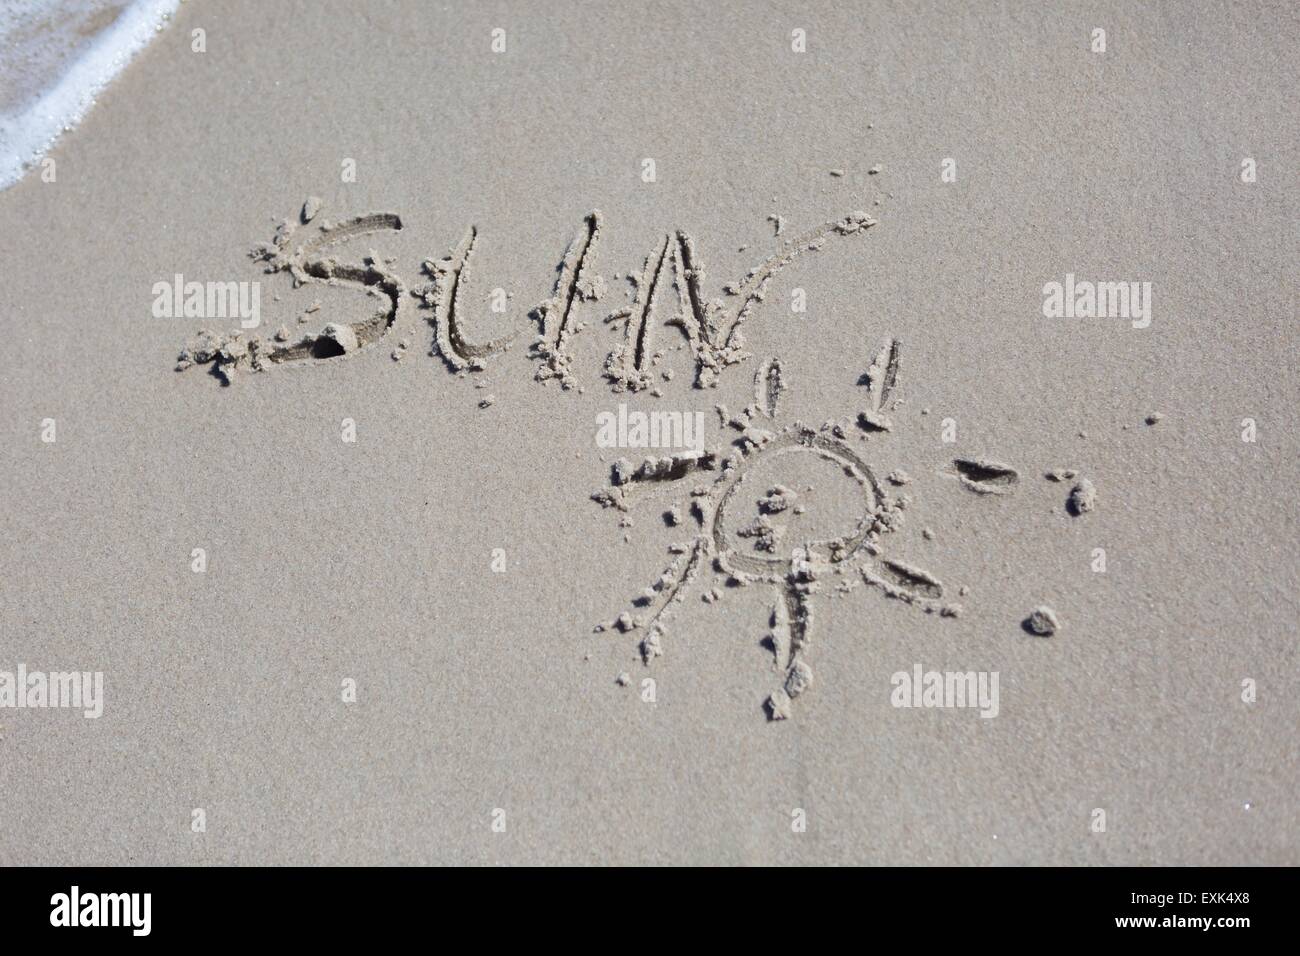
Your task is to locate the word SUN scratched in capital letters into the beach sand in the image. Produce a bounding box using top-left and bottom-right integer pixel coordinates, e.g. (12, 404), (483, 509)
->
(177, 198), (876, 392)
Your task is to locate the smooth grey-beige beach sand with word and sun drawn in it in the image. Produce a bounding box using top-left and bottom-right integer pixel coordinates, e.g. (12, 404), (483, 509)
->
(0, 3), (1300, 865)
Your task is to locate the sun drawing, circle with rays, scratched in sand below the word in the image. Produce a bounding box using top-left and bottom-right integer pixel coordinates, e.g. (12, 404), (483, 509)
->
(593, 339), (961, 721)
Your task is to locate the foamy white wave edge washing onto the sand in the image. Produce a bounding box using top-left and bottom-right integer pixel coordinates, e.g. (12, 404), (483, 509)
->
(0, 0), (181, 189)
